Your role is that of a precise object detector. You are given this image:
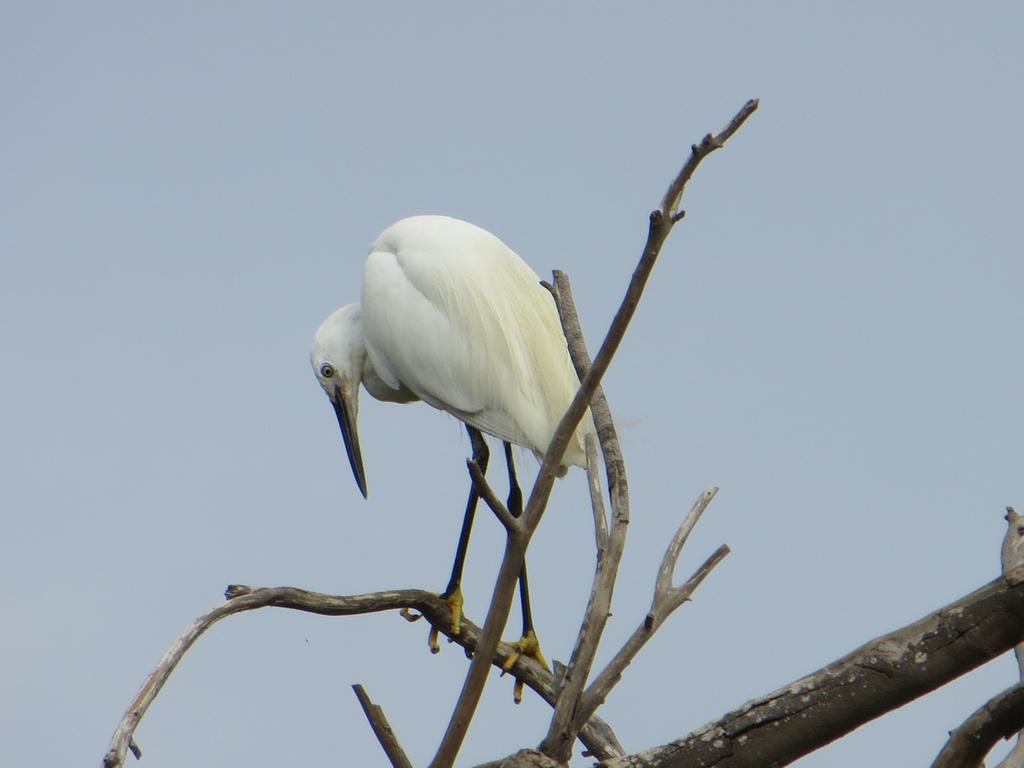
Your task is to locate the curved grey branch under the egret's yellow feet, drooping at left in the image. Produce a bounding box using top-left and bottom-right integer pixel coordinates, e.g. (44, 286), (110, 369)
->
(103, 585), (625, 768)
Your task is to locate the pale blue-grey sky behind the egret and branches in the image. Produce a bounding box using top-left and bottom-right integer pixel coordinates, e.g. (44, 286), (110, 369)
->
(0, 2), (1024, 768)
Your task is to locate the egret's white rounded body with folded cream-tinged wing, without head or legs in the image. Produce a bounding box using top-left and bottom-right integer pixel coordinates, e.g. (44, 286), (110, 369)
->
(362, 217), (579, 463)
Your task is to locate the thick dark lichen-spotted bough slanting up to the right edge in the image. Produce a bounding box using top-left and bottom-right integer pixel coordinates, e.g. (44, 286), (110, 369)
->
(599, 567), (1024, 768)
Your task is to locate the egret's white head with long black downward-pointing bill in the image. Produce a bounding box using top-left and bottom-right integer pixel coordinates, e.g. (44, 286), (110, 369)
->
(309, 304), (367, 499)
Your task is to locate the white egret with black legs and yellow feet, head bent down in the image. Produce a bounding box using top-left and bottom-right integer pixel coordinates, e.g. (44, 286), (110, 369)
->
(311, 216), (594, 659)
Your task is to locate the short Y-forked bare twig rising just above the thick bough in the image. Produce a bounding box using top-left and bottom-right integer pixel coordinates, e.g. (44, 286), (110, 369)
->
(573, 488), (729, 728)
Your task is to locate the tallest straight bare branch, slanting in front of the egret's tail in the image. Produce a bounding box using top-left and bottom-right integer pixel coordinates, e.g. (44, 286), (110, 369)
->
(430, 99), (758, 768)
